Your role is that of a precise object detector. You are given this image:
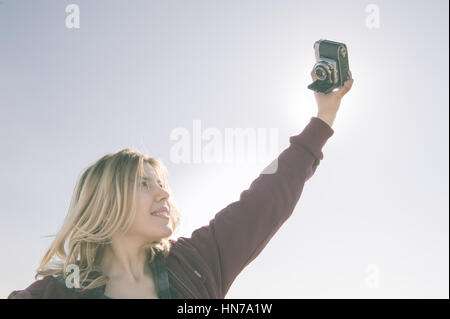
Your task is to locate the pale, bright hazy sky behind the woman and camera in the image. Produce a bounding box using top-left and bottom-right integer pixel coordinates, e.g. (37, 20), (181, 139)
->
(0, 0), (449, 298)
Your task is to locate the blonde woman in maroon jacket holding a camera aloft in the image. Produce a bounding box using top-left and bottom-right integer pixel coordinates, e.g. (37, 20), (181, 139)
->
(8, 72), (353, 299)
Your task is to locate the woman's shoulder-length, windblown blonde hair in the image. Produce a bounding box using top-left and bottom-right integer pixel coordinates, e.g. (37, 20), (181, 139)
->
(35, 148), (181, 291)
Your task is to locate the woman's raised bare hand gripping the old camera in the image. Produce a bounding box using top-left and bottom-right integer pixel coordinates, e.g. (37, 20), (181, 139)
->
(311, 69), (353, 127)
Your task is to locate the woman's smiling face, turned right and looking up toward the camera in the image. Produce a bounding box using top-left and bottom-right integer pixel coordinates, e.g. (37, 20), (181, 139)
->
(129, 163), (173, 241)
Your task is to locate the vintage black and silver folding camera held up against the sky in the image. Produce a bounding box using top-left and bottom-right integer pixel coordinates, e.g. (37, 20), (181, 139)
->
(308, 39), (352, 94)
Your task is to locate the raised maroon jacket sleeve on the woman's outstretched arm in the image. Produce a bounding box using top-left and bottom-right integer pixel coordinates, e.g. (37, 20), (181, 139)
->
(176, 117), (334, 297)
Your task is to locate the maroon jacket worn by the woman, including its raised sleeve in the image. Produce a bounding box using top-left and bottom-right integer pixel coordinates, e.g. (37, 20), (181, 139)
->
(8, 117), (334, 299)
